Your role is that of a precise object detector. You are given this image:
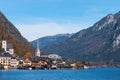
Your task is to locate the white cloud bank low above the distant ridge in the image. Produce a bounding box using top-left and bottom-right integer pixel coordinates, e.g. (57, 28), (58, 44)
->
(16, 23), (88, 41)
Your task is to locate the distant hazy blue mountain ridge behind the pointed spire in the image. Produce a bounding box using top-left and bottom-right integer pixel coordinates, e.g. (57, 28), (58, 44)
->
(31, 33), (72, 49)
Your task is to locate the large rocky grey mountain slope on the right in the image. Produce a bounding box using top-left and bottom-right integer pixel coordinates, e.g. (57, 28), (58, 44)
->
(43, 12), (120, 63)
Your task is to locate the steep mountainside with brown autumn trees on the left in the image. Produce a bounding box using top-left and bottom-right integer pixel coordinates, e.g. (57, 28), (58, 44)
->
(0, 12), (35, 56)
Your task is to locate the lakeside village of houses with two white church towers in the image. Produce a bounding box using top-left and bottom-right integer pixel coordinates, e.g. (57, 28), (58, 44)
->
(0, 40), (88, 70)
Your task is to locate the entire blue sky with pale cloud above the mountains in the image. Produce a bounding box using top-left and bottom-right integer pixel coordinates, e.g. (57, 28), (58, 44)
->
(0, 0), (120, 41)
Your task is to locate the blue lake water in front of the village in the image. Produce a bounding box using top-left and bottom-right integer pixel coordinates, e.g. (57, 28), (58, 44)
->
(0, 68), (120, 80)
